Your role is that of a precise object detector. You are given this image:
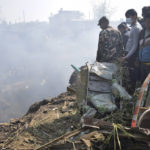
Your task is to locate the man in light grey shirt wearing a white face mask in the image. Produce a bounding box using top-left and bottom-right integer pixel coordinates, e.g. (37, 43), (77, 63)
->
(120, 9), (142, 90)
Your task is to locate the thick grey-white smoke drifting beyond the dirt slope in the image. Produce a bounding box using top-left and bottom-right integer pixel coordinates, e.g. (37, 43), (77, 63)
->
(0, 11), (99, 122)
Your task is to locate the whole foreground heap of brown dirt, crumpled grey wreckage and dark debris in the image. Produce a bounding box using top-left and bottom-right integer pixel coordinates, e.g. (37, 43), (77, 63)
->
(0, 63), (150, 150)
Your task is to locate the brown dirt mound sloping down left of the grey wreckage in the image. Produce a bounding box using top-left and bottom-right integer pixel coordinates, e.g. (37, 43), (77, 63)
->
(0, 92), (81, 149)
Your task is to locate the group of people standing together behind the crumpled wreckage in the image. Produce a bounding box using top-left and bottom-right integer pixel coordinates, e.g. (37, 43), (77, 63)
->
(96, 6), (150, 92)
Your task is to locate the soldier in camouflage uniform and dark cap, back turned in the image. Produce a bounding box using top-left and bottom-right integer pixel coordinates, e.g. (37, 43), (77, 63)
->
(96, 17), (123, 62)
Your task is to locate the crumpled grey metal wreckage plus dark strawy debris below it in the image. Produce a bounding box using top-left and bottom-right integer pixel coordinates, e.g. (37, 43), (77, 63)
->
(35, 63), (150, 150)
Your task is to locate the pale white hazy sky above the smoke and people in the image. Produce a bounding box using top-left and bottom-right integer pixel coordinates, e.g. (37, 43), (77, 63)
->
(0, 0), (150, 22)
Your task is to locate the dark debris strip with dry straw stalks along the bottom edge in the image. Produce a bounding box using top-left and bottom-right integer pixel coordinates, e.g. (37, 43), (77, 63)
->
(38, 124), (150, 150)
